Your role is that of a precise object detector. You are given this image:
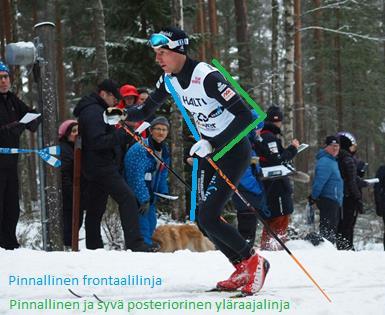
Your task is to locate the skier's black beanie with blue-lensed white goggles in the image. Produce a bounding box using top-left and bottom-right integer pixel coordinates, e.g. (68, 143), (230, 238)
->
(149, 26), (189, 55)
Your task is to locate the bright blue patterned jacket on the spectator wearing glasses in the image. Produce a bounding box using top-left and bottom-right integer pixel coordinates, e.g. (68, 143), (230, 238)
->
(124, 137), (170, 204)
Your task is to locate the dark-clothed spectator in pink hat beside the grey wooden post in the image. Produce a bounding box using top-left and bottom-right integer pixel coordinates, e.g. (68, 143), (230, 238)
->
(59, 119), (84, 247)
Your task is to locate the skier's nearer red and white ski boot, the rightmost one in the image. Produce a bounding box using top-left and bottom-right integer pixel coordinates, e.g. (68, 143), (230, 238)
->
(241, 253), (270, 295)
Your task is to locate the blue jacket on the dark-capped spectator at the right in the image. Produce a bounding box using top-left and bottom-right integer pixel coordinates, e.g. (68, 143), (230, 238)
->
(311, 149), (344, 206)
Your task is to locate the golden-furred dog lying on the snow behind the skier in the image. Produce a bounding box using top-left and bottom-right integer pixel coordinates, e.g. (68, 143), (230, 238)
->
(152, 224), (215, 253)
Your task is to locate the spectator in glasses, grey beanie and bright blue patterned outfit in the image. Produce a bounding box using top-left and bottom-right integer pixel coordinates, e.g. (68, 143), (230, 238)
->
(124, 116), (170, 251)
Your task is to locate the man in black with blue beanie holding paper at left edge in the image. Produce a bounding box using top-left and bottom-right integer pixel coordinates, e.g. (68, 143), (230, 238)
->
(0, 61), (39, 249)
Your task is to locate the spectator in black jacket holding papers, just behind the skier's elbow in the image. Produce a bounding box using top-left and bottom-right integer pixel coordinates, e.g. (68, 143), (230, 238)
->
(254, 106), (299, 250)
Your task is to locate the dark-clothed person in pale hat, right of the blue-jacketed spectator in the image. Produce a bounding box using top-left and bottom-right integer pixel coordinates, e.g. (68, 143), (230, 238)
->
(336, 131), (368, 250)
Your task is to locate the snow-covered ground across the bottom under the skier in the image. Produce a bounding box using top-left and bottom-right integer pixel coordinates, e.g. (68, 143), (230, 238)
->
(0, 240), (385, 315)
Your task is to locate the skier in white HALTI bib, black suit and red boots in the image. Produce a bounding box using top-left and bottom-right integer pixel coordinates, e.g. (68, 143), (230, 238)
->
(122, 26), (269, 295)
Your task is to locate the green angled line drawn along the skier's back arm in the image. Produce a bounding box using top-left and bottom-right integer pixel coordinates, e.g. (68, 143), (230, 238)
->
(211, 59), (266, 162)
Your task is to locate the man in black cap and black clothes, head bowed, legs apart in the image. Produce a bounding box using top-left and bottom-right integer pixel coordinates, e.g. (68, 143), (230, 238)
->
(74, 79), (152, 251)
